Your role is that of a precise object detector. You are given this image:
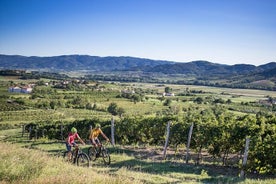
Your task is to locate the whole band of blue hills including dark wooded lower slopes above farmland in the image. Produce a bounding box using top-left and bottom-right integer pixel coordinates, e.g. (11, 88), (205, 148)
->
(0, 55), (276, 90)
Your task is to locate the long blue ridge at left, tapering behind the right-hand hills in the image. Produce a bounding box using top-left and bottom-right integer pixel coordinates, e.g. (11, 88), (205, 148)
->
(0, 55), (172, 72)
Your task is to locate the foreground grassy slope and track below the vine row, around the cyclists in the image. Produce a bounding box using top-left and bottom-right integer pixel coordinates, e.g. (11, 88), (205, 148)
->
(0, 129), (276, 184)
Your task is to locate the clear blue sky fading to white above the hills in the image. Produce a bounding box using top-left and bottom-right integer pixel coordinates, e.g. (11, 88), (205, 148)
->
(0, 0), (276, 65)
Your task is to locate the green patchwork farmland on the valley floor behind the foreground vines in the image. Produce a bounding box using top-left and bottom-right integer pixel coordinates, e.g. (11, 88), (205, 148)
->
(0, 78), (276, 124)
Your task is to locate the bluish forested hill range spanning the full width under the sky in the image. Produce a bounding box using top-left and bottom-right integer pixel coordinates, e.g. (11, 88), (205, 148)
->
(0, 55), (276, 77)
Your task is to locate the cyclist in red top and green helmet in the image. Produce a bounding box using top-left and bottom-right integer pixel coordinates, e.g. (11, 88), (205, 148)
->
(66, 127), (85, 160)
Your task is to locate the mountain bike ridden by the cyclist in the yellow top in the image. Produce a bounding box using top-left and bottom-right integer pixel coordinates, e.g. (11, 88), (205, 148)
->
(88, 144), (111, 165)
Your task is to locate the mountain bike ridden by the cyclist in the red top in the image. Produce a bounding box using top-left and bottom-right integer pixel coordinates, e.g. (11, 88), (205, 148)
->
(63, 146), (90, 167)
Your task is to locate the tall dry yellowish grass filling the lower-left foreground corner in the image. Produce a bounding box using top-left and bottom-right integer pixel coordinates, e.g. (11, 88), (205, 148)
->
(0, 143), (144, 184)
